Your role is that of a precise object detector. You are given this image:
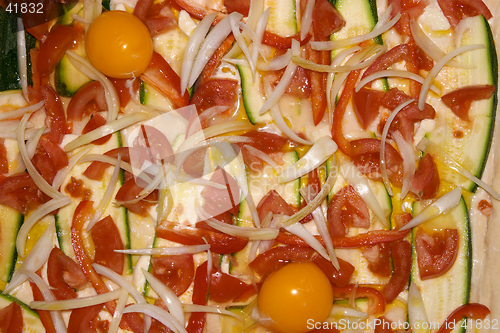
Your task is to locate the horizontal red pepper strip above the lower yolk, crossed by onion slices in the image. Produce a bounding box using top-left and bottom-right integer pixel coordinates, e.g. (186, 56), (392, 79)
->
(276, 230), (409, 249)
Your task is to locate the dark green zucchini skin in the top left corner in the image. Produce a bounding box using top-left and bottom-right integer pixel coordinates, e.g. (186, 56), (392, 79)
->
(0, 8), (36, 91)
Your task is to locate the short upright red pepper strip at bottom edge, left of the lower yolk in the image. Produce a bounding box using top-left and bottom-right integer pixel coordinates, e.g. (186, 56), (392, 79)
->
(186, 261), (210, 333)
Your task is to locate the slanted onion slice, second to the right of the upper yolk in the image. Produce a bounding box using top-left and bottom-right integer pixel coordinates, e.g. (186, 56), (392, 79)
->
(188, 12), (243, 87)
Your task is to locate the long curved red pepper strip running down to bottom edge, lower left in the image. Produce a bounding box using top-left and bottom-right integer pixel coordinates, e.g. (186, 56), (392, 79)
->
(71, 200), (144, 333)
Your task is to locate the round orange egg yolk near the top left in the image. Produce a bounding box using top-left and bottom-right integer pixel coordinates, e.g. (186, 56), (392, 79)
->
(85, 10), (153, 78)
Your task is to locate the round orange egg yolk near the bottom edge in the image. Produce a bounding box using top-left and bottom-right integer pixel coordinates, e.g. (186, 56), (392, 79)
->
(258, 262), (333, 333)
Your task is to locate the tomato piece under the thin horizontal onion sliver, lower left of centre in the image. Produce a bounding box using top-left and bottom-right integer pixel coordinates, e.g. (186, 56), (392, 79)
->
(151, 254), (194, 296)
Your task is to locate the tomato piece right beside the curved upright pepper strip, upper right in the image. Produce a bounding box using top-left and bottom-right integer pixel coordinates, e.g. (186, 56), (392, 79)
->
(353, 87), (385, 129)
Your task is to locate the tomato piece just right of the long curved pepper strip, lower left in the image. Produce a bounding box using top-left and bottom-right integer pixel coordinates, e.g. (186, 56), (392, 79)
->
(91, 215), (125, 275)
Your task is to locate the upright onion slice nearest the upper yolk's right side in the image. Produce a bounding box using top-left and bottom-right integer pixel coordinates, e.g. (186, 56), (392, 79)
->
(181, 13), (217, 95)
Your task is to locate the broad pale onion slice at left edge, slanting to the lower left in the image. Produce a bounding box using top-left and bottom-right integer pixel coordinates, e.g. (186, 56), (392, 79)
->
(3, 222), (56, 294)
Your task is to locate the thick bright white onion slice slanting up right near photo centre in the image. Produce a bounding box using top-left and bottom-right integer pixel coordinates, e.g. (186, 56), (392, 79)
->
(278, 136), (338, 183)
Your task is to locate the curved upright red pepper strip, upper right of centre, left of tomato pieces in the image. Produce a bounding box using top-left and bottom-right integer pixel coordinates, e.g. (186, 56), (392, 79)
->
(332, 69), (361, 155)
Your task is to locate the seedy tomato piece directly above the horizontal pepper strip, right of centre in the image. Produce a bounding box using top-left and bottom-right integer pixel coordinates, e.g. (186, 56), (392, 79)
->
(327, 186), (370, 238)
